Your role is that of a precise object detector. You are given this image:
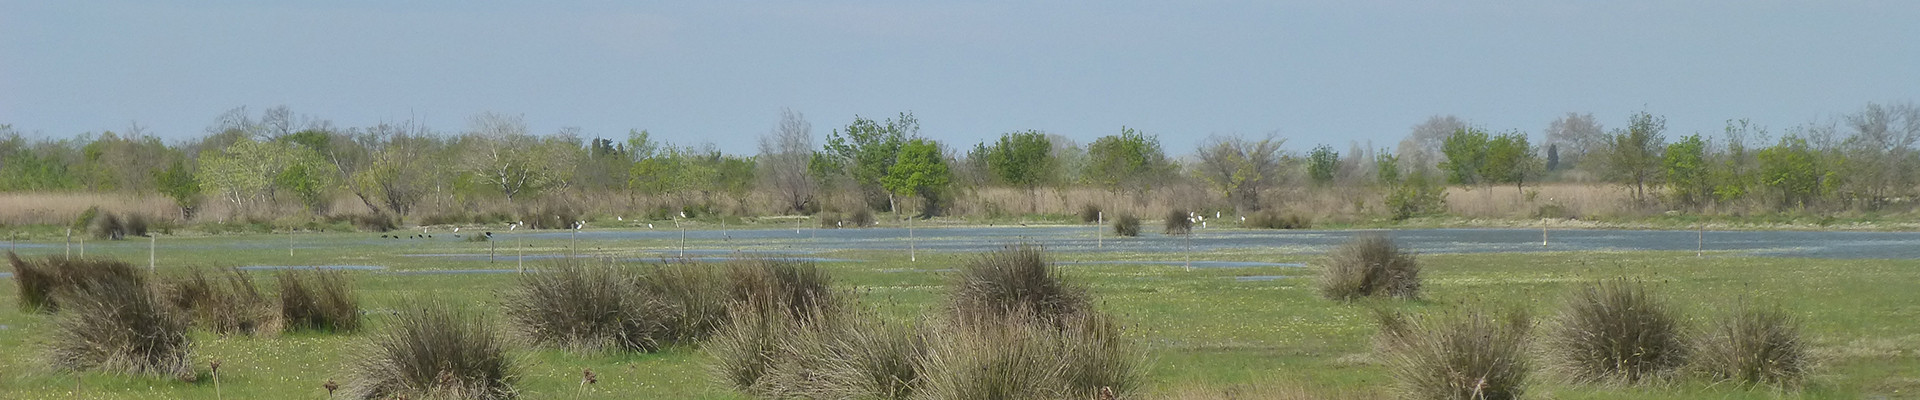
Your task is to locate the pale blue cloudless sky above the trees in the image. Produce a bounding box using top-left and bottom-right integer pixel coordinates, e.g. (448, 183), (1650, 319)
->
(0, 0), (1920, 154)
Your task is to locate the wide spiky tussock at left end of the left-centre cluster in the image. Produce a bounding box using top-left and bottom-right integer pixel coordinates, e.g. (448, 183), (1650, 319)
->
(501, 260), (672, 352)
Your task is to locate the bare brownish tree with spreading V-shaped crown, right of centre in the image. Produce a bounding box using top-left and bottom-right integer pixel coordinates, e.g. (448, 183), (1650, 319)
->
(1194, 135), (1286, 213)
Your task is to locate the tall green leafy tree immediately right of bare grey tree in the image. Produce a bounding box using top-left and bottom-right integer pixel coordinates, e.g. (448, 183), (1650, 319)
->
(824, 112), (920, 210)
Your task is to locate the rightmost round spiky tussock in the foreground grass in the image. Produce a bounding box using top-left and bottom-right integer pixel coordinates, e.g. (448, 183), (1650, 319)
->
(1693, 304), (1812, 388)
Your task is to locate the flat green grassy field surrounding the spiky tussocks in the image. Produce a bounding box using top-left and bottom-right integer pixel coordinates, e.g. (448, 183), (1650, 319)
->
(0, 233), (1920, 398)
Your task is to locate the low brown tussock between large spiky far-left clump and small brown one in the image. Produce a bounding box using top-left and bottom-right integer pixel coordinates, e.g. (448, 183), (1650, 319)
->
(159, 267), (280, 335)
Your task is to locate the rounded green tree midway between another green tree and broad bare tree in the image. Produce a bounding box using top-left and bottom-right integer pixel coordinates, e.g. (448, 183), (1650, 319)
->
(1081, 127), (1175, 194)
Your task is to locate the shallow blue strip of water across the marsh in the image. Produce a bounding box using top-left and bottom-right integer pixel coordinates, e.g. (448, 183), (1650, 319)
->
(526, 225), (1920, 260)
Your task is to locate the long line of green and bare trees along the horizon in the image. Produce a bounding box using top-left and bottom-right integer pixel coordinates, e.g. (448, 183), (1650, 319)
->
(0, 104), (1920, 225)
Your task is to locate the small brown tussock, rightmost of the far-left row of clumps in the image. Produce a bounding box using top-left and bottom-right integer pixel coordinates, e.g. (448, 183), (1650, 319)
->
(278, 269), (361, 333)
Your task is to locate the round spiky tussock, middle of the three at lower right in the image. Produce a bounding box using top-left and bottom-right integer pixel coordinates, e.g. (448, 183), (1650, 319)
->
(1546, 279), (1688, 383)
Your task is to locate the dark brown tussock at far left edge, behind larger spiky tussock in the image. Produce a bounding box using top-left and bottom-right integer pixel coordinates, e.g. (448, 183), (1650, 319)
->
(6, 252), (144, 313)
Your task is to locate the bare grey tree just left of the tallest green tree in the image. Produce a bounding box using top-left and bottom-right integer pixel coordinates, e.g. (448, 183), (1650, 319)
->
(758, 110), (814, 213)
